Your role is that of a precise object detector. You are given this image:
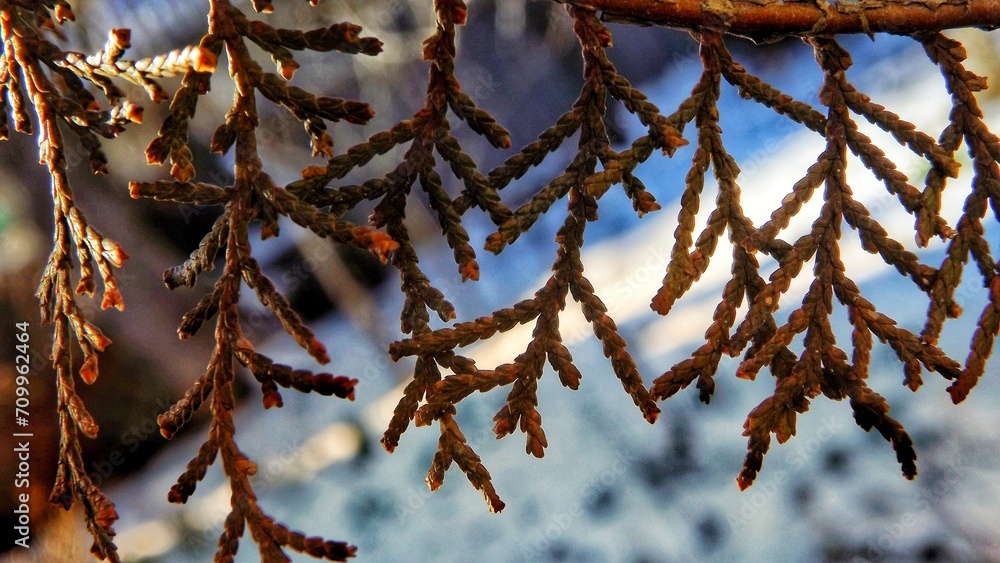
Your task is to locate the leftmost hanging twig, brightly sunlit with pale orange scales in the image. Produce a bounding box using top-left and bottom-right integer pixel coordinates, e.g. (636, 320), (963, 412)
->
(0, 0), (205, 560)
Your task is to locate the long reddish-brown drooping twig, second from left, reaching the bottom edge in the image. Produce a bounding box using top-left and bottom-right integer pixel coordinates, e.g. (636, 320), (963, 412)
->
(130, 0), (399, 561)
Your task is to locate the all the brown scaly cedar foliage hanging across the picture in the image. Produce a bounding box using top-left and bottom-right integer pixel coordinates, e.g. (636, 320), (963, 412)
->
(0, 0), (1000, 561)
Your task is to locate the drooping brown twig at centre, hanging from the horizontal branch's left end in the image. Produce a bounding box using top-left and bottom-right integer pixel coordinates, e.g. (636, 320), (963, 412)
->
(383, 4), (686, 511)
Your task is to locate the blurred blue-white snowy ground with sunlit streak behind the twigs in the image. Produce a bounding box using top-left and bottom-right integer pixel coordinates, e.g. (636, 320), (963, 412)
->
(109, 33), (1000, 562)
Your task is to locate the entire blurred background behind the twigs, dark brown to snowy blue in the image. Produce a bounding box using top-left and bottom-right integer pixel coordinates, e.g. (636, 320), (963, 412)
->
(0, 0), (1000, 563)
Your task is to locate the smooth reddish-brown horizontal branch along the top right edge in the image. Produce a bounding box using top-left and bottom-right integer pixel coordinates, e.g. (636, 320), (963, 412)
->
(555, 0), (1000, 41)
